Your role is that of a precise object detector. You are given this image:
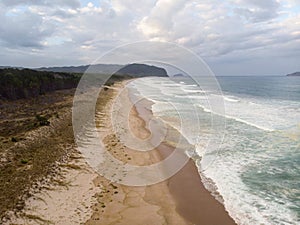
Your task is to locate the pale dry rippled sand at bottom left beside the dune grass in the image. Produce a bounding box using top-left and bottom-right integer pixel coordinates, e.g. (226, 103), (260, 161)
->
(7, 152), (101, 225)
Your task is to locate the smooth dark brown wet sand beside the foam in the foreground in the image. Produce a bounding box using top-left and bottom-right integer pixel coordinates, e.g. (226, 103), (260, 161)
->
(164, 150), (236, 225)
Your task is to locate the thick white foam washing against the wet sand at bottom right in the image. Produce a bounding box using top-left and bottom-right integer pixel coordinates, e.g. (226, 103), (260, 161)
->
(202, 148), (297, 225)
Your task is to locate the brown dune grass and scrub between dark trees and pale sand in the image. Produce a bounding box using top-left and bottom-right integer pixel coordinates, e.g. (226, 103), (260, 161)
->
(0, 90), (74, 220)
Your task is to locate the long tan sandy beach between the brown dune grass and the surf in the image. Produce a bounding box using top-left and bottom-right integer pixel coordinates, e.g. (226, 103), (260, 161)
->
(7, 82), (235, 225)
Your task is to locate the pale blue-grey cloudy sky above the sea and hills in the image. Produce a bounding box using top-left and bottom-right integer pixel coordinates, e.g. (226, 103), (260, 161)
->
(0, 0), (300, 75)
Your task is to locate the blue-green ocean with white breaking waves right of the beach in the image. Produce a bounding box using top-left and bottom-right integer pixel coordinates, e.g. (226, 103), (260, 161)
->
(128, 76), (300, 225)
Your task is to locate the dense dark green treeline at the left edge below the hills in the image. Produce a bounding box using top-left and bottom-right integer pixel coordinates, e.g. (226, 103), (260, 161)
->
(0, 68), (81, 100)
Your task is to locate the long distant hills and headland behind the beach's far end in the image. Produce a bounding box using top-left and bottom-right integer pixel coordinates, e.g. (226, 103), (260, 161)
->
(36, 64), (168, 77)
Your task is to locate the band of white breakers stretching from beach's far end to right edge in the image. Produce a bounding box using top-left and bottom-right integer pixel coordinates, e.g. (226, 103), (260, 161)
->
(131, 78), (300, 131)
